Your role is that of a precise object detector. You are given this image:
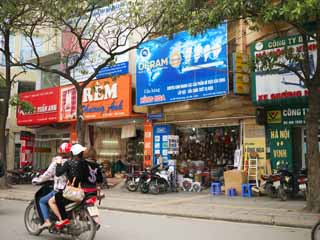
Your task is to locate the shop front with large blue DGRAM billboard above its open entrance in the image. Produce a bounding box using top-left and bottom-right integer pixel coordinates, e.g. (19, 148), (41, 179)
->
(136, 24), (265, 191)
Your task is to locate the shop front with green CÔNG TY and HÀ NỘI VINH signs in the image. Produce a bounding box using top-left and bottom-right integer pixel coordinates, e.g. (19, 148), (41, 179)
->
(251, 36), (316, 172)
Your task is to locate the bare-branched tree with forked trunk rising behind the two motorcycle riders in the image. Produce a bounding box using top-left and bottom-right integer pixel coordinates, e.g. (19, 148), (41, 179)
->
(23, 0), (179, 144)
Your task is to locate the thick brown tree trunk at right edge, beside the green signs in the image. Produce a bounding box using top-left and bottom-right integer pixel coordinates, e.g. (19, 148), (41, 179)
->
(306, 86), (320, 212)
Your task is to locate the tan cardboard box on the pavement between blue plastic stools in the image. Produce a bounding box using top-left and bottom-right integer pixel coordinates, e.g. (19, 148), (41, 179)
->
(224, 170), (248, 195)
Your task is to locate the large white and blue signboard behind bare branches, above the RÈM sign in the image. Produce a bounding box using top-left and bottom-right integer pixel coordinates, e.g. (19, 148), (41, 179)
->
(60, 1), (129, 86)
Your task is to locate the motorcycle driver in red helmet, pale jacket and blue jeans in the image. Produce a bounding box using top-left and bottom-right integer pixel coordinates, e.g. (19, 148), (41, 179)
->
(32, 142), (72, 229)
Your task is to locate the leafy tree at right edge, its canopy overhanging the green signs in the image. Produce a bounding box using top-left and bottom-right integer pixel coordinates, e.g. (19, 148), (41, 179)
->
(179, 0), (320, 212)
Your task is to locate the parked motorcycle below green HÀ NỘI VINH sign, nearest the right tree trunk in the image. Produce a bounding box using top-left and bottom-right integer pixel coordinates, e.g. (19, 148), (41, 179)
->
(278, 169), (308, 201)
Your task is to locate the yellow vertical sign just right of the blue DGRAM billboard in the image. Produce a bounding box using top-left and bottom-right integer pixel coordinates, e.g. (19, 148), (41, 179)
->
(232, 52), (250, 94)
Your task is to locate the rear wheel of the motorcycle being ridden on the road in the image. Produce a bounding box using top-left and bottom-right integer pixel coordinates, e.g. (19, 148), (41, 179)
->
(71, 209), (97, 240)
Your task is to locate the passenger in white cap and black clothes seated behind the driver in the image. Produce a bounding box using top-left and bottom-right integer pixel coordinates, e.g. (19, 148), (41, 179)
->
(55, 143), (102, 228)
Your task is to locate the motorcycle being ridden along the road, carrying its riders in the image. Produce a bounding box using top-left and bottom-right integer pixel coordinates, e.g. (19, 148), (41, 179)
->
(24, 181), (101, 240)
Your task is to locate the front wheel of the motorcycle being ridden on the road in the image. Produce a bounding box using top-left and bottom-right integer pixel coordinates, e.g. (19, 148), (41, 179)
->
(24, 202), (42, 236)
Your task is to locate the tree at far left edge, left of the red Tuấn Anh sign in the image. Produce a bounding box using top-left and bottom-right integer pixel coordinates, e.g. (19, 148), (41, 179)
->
(0, 0), (40, 185)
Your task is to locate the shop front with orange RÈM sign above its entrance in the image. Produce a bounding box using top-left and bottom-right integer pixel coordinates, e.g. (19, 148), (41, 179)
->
(60, 75), (145, 175)
